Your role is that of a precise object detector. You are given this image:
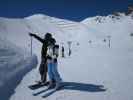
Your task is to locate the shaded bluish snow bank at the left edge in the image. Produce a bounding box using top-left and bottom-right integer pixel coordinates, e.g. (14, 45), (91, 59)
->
(0, 39), (37, 100)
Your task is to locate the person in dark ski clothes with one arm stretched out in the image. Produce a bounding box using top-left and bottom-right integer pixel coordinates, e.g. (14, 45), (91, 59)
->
(29, 33), (52, 85)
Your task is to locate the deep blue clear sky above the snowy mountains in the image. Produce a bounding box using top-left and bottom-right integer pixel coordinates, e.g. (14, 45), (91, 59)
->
(0, 0), (133, 21)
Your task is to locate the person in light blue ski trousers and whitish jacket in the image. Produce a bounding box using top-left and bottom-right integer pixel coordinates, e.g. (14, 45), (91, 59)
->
(47, 39), (62, 89)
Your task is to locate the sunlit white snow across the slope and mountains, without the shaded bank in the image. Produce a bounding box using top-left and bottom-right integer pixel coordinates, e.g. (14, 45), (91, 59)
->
(0, 14), (133, 100)
